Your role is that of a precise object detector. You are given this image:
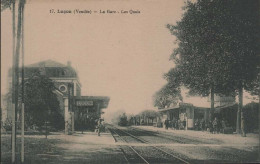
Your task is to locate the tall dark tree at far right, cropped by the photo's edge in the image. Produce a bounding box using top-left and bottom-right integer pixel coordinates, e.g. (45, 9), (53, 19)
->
(220, 0), (260, 136)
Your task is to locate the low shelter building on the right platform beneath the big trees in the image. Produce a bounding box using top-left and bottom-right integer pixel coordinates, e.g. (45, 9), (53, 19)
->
(158, 95), (236, 129)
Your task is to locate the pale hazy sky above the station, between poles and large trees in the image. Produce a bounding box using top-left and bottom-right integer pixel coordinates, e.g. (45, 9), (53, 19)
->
(1, 0), (184, 114)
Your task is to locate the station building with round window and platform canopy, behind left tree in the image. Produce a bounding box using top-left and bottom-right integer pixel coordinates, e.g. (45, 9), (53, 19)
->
(7, 60), (110, 134)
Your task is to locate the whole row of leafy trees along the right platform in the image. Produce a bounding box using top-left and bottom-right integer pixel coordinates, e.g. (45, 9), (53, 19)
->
(154, 0), (260, 136)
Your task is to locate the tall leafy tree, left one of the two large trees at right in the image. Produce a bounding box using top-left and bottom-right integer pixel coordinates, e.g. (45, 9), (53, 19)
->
(167, 0), (234, 119)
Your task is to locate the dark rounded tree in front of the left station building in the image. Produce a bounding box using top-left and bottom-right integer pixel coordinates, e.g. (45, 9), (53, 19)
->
(24, 74), (64, 129)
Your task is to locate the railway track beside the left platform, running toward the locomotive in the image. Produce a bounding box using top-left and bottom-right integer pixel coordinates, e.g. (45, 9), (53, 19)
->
(108, 125), (189, 164)
